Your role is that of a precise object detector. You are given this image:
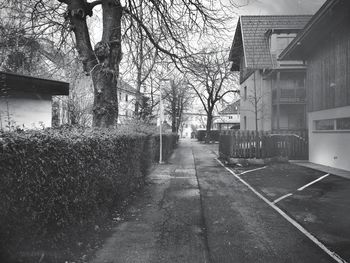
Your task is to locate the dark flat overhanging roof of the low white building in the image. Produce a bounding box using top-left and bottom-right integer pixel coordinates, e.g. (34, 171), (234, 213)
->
(0, 71), (69, 95)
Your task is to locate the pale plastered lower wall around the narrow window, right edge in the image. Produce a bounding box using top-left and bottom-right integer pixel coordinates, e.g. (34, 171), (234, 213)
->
(308, 106), (350, 171)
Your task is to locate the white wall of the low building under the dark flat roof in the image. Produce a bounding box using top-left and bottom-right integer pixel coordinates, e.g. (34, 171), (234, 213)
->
(0, 93), (52, 129)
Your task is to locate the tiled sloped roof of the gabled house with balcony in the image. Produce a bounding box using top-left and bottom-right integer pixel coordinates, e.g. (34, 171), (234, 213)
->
(229, 15), (312, 70)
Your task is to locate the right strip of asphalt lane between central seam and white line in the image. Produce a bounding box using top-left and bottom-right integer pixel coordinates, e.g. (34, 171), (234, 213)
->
(193, 143), (335, 262)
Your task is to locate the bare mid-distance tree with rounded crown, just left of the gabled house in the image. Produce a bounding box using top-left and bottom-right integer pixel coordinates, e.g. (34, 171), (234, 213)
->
(187, 50), (239, 142)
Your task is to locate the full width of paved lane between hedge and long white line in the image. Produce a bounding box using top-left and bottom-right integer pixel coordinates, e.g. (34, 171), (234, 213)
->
(93, 141), (348, 263)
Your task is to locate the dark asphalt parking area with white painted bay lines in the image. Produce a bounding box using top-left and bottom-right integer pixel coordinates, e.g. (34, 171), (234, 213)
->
(229, 163), (350, 262)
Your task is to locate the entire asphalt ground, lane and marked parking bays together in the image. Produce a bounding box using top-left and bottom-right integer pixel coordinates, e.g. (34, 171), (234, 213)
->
(91, 140), (350, 263)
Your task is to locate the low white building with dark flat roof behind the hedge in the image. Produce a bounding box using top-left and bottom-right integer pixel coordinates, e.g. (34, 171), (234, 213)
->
(0, 71), (69, 130)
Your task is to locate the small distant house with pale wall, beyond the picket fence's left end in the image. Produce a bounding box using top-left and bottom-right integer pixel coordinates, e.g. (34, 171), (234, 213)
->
(214, 100), (240, 130)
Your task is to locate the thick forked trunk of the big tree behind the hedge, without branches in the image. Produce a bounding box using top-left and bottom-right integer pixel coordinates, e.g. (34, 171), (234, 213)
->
(61, 0), (123, 128)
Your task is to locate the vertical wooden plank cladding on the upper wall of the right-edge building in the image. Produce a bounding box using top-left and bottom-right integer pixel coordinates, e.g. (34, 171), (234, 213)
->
(306, 23), (350, 111)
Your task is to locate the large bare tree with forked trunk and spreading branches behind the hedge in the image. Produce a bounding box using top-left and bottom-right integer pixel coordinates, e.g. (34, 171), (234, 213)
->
(22, 0), (238, 127)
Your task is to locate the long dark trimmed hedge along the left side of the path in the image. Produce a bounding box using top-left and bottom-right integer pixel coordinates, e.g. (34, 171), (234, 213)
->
(0, 130), (177, 260)
